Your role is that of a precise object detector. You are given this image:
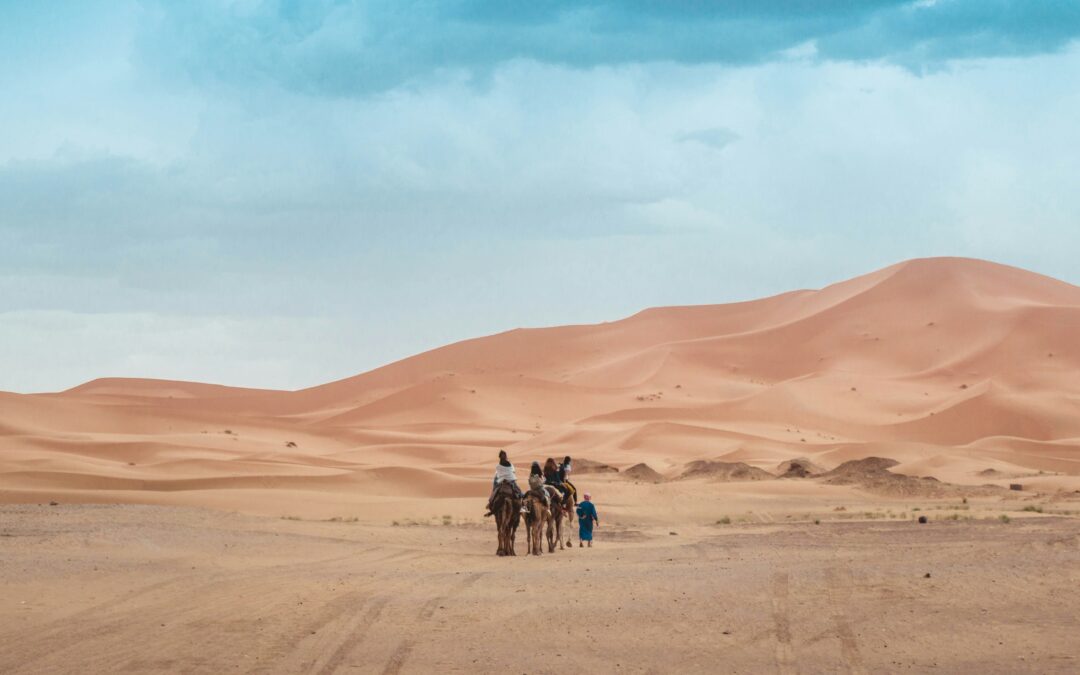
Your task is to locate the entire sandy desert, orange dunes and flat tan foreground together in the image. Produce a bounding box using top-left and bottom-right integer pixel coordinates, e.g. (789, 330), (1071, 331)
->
(0, 258), (1080, 672)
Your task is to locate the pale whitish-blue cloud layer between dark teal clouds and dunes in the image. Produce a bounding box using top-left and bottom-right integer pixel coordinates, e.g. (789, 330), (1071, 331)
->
(0, 15), (1080, 390)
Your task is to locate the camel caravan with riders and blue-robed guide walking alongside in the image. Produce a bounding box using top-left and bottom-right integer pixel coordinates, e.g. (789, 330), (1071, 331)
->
(485, 450), (598, 555)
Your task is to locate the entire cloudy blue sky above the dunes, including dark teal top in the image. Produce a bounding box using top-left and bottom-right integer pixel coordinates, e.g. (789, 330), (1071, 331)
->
(0, 0), (1080, 392)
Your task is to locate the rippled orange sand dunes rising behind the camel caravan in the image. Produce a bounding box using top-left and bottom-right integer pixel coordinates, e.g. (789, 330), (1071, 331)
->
(0, 258), (1080, 508)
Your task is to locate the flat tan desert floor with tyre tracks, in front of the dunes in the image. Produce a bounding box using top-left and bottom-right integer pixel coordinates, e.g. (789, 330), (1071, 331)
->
(0, 502), (1080, 673)
